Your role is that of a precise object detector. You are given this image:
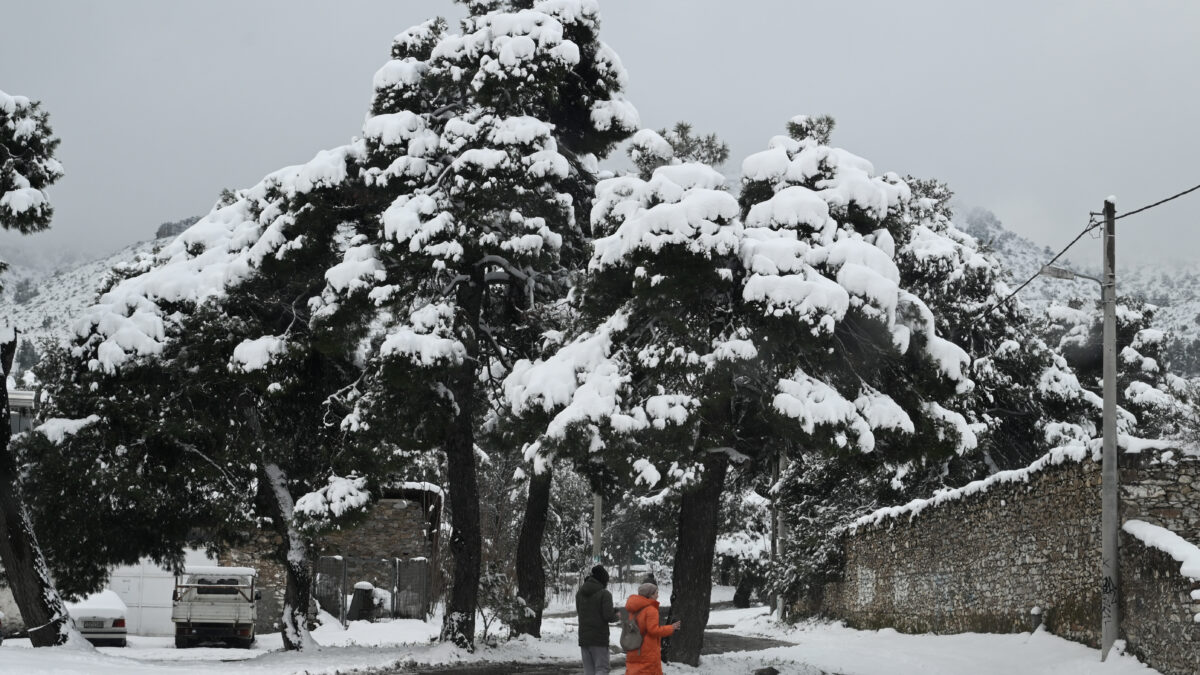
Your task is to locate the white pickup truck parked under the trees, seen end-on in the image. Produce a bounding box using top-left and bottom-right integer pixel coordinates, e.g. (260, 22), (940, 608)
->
(170, 566), (262, 647)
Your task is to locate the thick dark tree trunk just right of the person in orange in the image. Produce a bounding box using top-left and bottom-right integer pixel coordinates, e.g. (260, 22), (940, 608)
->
(666, 453), (730, 665)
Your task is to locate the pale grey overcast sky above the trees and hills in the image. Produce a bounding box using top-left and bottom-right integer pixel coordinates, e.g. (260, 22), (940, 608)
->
(0, 0), (1200, 267)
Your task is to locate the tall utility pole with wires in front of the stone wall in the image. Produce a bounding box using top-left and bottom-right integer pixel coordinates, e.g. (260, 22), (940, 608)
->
(1100, 197), (1121, 661)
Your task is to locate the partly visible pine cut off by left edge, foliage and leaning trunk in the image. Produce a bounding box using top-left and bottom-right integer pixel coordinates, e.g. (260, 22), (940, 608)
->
(0, 86), (70, 647)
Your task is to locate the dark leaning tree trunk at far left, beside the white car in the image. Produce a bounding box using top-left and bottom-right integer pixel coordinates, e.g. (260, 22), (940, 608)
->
(0, 336), (68, 647)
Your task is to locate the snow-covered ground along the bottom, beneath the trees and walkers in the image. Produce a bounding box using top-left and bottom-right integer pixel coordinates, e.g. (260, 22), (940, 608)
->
(0, 598), (1156, 675)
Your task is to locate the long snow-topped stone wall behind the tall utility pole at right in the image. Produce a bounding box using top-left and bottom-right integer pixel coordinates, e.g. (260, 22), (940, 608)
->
(798, 452), (1200, 674)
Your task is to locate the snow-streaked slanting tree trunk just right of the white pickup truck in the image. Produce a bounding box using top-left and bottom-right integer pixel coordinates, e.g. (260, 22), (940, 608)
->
(263, 462), (317, 651)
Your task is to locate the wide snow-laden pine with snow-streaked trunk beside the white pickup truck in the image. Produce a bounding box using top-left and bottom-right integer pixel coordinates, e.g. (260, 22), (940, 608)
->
(44, 141), (379, 650)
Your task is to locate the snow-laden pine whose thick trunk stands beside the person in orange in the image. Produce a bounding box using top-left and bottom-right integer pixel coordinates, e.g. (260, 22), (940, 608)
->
(508, 118), (998, 663)
